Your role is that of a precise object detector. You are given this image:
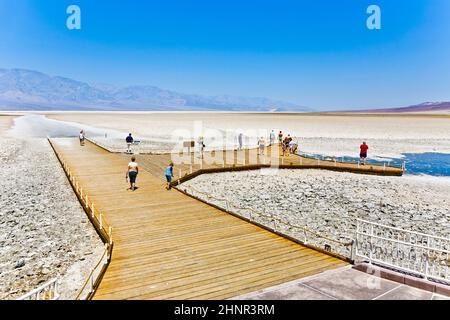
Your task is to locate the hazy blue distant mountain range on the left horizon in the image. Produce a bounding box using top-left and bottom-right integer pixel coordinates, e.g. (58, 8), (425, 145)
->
(0, 69), (313, 112)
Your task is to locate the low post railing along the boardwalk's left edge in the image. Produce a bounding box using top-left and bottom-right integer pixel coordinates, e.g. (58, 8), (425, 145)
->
(49, 140), (114, 300)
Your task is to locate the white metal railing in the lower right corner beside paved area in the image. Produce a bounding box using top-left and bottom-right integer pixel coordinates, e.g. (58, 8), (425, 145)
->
(355, 219), (450, 282)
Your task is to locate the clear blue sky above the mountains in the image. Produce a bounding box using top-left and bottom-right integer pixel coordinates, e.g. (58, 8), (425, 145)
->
(0, 0), (450, 110)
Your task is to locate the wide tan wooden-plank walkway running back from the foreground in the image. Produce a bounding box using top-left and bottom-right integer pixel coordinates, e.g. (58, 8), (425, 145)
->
(52, 139), (346, 299)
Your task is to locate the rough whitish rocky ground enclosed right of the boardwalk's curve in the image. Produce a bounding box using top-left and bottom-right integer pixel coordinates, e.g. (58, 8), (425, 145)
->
(183, 170), (450, 255)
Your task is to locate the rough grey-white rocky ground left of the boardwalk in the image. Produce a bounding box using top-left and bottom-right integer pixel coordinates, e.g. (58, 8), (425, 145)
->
(0, 137), (103, 299)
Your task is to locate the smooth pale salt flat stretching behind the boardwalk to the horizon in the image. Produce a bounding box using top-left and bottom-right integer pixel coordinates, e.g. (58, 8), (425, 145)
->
(47, 112), (450, 159)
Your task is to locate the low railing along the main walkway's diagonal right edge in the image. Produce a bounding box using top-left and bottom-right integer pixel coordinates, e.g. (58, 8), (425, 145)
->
(177, 185), (354, 261)
